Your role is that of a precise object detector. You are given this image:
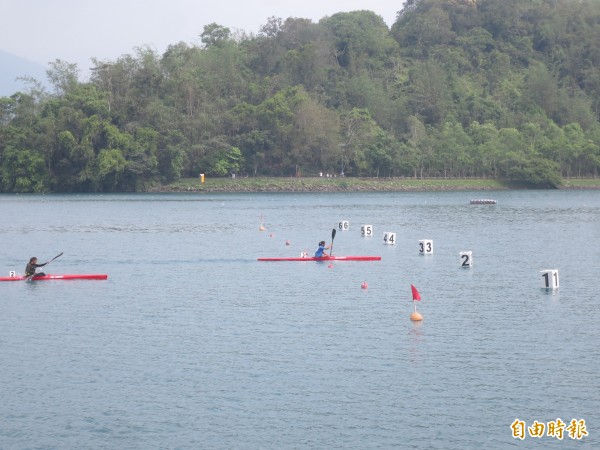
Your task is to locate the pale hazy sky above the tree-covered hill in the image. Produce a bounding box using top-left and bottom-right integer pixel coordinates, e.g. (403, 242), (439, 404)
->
(0, 0), (403, 72)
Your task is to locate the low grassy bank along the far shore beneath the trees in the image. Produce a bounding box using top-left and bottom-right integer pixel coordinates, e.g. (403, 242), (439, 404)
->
(151, 177), (600, 192)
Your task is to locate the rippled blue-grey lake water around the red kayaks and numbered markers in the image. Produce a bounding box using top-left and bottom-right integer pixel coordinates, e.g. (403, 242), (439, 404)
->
(0, 191), (600, 449)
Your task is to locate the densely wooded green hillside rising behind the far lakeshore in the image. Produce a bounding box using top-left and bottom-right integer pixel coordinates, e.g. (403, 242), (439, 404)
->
(0, 0), (600, 192)
